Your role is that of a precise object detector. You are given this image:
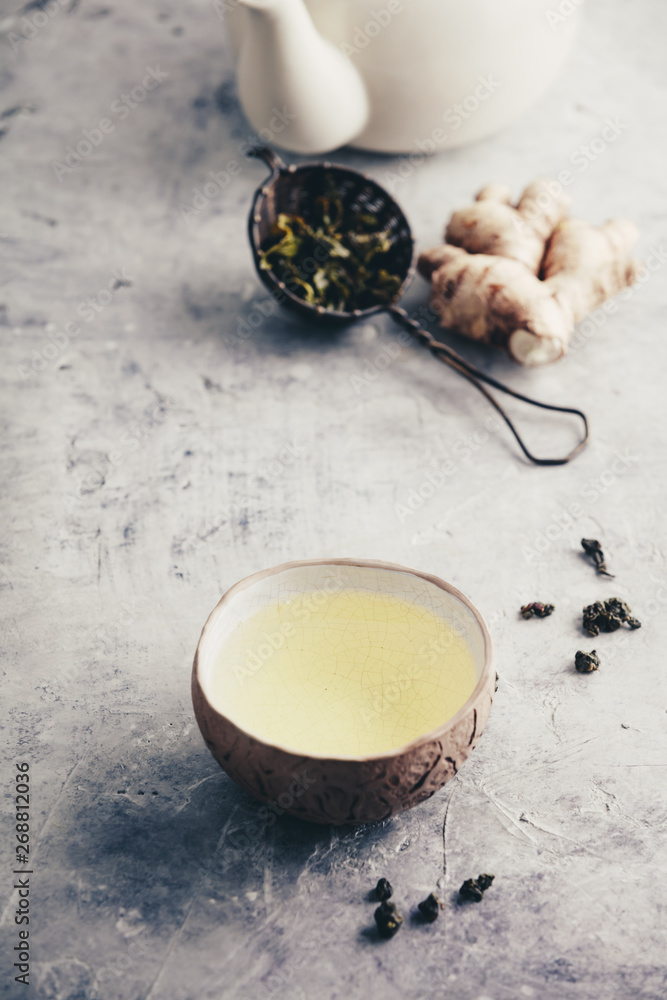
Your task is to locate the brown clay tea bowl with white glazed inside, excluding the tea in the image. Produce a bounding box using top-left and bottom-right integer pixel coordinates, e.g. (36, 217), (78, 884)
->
(192, 559), (496, 824)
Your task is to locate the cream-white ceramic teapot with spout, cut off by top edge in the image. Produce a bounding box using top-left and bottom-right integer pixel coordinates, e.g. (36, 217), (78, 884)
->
(227, 0), (583, 153)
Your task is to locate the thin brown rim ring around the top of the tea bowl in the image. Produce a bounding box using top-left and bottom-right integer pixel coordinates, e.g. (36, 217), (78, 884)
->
(192, 558), (494, 763)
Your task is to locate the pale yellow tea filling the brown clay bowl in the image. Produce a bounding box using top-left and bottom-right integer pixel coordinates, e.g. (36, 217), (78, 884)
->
(211, 590), (477, 757)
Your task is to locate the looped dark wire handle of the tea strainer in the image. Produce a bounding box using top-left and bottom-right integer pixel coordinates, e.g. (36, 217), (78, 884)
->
(389, 306), (589, 465)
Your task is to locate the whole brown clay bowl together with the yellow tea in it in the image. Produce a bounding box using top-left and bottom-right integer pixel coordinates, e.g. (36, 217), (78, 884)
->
(192, 559), (495, 824)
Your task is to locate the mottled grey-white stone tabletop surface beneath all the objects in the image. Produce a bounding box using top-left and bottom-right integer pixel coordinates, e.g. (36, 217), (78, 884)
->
(0, 0), (667, 1000)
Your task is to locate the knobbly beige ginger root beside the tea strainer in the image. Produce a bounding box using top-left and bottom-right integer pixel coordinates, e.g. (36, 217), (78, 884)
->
(417, 181), (640, 365)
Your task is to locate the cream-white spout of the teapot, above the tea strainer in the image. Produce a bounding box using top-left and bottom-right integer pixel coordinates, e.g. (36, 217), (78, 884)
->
(238, 0), (369, 153)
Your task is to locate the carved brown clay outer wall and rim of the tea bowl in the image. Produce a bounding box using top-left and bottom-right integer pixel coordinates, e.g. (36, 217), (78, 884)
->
(192, 559), (496, 825)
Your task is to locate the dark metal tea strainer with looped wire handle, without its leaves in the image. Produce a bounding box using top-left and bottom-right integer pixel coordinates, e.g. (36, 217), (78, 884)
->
(248, 146), (589, 465)
